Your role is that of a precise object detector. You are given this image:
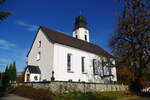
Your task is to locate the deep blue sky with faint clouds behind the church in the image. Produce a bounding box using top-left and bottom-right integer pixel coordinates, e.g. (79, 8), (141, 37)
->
(0, 0), (121, 71)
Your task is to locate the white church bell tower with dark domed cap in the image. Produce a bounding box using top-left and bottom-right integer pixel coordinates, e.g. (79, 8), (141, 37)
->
(73, 16), (90, 42)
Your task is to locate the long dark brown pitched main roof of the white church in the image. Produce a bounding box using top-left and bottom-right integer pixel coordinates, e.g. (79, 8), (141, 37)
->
(39, 26), (112, 57)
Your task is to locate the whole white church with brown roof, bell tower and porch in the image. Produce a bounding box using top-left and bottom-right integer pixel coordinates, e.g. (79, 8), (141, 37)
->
(24, 16), (117, 83)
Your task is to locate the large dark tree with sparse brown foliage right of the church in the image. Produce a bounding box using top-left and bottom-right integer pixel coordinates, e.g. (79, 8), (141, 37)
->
(110, 0), (150, 92)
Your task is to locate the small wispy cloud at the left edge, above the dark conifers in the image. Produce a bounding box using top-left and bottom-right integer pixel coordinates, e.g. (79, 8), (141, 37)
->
(0, 39), (16, 50)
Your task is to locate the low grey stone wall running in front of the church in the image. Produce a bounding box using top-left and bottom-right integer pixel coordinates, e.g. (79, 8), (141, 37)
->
(12, 81), (128, 93)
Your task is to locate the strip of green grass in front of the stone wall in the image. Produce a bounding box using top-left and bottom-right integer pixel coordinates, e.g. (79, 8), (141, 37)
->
(55, 91), (132, 100)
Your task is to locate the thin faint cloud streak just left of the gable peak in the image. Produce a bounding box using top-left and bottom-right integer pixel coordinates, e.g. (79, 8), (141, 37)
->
(16, 20), (38, 31)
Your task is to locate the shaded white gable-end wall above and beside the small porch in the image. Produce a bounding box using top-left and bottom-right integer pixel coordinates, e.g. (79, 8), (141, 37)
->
(28, 30), (53, 81)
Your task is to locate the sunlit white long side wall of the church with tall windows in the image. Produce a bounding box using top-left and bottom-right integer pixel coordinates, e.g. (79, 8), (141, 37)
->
(54, 43), (113, 83)
